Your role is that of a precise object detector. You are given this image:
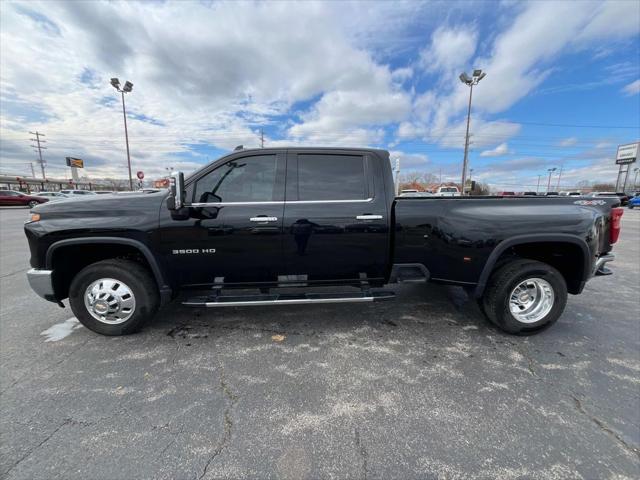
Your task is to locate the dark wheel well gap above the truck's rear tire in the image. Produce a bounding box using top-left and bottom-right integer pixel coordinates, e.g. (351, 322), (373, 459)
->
(494, 242), (585, 294)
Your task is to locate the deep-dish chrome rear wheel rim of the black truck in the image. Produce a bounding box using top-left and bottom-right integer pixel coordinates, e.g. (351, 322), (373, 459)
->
(509, 278), (555, 323)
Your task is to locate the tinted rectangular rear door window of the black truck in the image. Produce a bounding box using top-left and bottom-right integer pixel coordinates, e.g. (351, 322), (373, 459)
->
(298, 155), (367, 200)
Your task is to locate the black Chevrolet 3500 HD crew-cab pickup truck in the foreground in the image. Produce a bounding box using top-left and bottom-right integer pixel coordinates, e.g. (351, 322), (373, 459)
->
(25, 148), (622, 335)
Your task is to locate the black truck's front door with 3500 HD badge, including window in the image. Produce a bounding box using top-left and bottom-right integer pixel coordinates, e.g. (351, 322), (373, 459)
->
(161, 151), (285, 286)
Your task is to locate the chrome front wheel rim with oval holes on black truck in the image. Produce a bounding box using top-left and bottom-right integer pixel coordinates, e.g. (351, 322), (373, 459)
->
(84, 278), (136, 325)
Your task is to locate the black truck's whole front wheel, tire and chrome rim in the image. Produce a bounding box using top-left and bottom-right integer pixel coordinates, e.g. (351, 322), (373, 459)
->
(69, 259), (160, 335)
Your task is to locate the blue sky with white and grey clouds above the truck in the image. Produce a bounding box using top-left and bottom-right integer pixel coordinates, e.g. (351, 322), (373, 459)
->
(0, 0), (640, 189)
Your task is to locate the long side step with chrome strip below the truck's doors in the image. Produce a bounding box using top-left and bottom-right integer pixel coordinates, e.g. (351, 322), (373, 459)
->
(182, 290), (395, 307)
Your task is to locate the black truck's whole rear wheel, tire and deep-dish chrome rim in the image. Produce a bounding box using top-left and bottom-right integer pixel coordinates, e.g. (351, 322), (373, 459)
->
(482, 259), (567, 335)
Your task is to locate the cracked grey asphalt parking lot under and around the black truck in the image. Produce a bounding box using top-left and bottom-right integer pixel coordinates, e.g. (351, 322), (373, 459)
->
(0, 209), (640, 479)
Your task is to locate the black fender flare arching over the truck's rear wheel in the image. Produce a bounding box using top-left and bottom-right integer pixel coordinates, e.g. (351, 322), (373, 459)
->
(474, 233), (591, 298)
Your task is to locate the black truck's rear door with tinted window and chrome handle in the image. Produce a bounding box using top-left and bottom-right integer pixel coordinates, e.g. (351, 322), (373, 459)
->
(283, 150), (389, 283)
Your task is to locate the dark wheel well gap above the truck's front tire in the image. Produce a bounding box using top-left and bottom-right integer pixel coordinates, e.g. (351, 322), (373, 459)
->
(51, 243), (152, 300)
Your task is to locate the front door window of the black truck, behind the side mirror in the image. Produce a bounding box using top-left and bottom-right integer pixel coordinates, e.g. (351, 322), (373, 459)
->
(194, 155), (277, 203)
